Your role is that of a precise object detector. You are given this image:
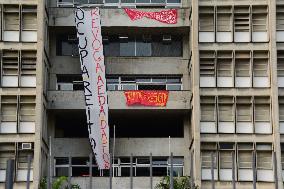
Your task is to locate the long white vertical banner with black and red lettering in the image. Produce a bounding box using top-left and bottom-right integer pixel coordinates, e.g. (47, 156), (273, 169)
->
(75, 8), (110, 169)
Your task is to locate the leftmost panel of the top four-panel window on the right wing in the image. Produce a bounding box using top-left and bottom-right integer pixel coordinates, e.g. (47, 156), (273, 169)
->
(199, 7), (215, 42)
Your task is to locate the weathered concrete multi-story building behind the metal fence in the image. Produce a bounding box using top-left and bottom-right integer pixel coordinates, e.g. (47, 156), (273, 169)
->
(0, 0), (284, 189)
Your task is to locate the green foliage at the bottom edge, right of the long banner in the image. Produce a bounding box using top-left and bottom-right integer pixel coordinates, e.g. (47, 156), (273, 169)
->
(155, 176), (198, 189)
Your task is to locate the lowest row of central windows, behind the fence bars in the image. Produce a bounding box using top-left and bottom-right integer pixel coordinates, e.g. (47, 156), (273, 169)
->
(55, 156), (184, 177)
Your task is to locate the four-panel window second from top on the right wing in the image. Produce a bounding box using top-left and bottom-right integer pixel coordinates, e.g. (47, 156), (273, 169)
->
(199, 51), (270, 88)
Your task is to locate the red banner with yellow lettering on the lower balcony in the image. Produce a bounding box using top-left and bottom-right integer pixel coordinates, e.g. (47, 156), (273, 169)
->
(124, 91), (169, 106)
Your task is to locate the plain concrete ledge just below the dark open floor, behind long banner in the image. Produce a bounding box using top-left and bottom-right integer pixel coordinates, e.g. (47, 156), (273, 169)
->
(53, 137), (188, 157)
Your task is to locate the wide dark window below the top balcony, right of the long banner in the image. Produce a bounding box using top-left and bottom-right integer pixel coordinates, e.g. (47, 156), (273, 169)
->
(91, 34), (183, 57)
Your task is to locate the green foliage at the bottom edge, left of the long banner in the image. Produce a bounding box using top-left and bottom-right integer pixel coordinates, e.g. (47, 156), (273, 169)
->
(39, 176), (81, 189)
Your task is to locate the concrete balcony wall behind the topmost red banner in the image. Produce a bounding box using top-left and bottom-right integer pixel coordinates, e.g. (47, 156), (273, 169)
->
(49, 7), (190, 28)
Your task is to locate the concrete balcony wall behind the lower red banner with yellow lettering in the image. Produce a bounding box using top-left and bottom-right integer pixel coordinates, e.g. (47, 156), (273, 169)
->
(48, 91), (191, 110)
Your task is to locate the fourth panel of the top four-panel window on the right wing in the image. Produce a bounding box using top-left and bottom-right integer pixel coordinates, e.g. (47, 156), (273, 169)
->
(252, 6), (268, 42)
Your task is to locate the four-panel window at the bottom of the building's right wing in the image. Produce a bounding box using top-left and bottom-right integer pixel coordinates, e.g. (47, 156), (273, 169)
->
(201, 143), (274, 182)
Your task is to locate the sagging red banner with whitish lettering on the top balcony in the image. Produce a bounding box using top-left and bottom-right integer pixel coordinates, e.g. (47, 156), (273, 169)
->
(124, 8), (177, 24)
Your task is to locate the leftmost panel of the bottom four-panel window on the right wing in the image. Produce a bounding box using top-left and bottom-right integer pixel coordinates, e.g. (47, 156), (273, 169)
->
(201, 143), (218, 180)
